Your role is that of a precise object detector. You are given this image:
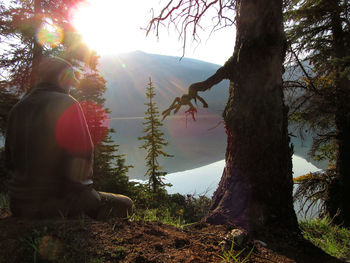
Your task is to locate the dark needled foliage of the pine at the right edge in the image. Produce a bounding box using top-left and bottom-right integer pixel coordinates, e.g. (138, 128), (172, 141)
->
(285, 0), (350, 162)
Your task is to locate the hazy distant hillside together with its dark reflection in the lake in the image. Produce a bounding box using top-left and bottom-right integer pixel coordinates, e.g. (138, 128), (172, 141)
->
(101, 51), (326, 179)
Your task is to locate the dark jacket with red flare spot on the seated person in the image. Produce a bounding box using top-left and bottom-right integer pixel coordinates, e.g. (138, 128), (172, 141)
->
(5, 83), (93, 203)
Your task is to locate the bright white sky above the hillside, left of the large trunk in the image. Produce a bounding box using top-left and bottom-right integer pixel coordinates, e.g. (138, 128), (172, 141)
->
(72, 0), (235, 65)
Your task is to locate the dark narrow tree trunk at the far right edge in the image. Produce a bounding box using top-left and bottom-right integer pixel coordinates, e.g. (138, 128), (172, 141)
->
(328, 1), (350, 227)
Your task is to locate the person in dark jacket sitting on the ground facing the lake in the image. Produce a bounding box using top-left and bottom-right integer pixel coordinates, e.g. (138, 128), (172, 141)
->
(5, 57), (132, 219)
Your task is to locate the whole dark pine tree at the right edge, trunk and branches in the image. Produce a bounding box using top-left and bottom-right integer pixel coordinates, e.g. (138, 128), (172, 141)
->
(286, 0), (350, 226)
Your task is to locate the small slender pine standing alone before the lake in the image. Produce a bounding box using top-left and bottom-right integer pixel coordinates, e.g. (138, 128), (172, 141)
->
(138, 78), (172, 193)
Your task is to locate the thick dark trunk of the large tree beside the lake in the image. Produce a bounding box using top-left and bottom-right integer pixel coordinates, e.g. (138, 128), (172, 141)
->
(206, 0), (297, 233)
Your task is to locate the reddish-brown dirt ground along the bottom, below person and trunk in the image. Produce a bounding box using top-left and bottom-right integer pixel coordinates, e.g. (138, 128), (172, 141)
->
(0, 210), (341, 263)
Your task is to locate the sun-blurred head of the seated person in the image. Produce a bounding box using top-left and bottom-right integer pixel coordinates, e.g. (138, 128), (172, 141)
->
(38, 57), (79, 93)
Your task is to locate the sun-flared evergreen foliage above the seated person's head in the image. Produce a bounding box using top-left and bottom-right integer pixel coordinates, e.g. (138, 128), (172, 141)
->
(0, 0), (88, 94)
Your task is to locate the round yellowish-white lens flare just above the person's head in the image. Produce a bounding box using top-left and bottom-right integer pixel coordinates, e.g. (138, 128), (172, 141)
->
(36, 21), (63, 48)
